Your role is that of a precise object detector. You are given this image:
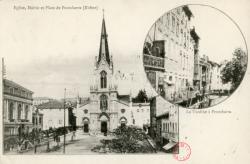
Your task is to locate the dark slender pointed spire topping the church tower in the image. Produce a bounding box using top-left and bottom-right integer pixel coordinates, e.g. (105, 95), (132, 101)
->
(98, 10), (110, 65)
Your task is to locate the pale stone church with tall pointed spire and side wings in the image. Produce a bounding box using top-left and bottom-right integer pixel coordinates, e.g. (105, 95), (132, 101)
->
(75, 14), (150, 134)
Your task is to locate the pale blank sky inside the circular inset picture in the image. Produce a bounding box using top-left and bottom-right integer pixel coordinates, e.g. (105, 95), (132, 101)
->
(189, 5), (246, 63)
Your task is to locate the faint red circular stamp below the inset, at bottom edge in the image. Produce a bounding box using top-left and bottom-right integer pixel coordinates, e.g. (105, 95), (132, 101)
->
(173, 142), (191, 161)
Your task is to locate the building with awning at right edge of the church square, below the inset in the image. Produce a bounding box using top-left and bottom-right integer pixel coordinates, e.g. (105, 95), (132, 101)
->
(150, 96), (179, 151)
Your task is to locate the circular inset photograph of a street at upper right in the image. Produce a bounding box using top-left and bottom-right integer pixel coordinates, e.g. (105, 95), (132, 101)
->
(142, 4), (248, 109)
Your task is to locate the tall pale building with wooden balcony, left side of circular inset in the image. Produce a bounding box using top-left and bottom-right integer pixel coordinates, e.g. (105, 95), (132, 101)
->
(143, 6), (195, 102)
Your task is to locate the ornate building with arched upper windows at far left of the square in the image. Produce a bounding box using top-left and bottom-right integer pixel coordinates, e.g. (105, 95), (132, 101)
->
(3, 79), (33, 150)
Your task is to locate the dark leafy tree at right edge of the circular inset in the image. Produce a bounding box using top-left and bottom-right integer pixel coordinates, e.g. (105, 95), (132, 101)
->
(221, 48), (247, 92)
